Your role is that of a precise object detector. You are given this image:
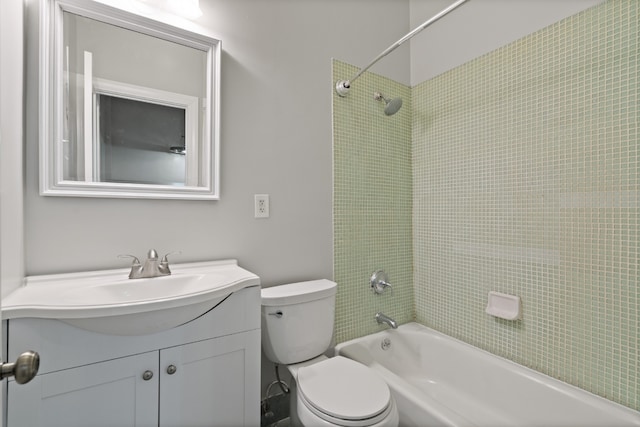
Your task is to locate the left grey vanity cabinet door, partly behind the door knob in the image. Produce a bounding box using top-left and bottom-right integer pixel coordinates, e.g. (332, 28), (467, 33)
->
(7, 351), (159, 427)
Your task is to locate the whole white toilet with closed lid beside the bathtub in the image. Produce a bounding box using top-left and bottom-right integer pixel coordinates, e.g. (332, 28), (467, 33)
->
(262, 279), (399, 427)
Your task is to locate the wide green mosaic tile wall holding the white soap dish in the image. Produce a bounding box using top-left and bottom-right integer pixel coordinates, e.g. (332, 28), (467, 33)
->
(412, 0), (640, 410)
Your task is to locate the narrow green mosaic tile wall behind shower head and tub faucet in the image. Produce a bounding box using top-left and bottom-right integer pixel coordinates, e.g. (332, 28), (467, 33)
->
(333, 61), (414, 342)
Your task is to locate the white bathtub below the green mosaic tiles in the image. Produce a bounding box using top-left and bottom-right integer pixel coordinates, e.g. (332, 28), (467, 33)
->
(336, 323), (640, 427)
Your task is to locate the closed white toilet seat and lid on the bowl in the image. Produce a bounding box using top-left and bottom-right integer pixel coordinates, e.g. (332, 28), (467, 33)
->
(297, 356), (392, 426)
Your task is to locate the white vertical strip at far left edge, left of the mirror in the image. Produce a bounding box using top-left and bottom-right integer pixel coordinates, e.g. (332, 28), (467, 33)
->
(0, 0), (24, 295)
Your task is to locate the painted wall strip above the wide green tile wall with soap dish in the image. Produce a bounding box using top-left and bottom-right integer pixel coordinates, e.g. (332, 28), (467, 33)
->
(410, 0), (603, 86)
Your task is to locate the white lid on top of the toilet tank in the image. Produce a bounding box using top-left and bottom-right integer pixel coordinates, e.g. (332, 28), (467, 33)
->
(261, 279), (338, 306)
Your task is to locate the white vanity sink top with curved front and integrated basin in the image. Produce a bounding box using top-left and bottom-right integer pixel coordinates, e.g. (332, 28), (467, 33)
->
(2, 260), (260, 335)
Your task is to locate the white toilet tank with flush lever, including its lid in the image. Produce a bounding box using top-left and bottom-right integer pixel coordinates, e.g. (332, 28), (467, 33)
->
(262, 279), (337, 365)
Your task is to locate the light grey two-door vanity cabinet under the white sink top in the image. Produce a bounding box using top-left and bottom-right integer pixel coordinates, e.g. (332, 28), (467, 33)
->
(7, 286), (260, 427)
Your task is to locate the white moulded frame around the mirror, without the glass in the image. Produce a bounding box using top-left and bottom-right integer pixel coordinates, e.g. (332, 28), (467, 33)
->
(39, 0), (222, 200)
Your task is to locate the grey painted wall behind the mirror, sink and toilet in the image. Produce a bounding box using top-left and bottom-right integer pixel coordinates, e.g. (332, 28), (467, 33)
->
(23, 0), (409, 285)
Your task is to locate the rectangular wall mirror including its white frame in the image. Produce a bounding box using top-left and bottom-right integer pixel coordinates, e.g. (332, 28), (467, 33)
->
(40, 0), (221, 200)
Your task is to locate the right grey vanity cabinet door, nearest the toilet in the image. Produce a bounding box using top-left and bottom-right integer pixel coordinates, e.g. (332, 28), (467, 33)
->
(160, 330), (260, 427)
